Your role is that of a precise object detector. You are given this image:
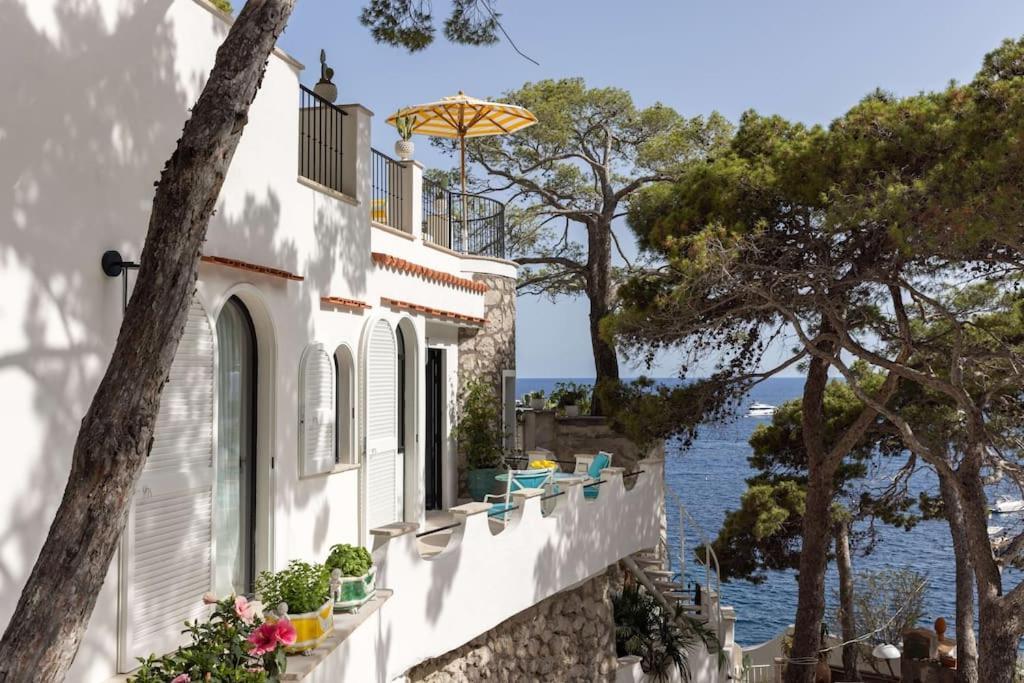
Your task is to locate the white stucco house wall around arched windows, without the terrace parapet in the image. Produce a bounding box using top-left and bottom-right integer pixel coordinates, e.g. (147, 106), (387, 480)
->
(0, 0), (515, 682)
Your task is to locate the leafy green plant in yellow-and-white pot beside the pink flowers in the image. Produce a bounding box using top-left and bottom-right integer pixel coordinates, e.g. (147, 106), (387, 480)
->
(255, 560), (334, 653)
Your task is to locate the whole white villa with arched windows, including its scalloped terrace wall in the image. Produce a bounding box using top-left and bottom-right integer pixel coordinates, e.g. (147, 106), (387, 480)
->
(0, 0), (692, 682)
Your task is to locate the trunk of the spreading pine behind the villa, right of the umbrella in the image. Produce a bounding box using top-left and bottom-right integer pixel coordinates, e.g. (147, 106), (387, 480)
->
(587, 220), (618, 415)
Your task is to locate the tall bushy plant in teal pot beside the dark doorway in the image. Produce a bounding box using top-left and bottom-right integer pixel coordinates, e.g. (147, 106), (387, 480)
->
(455, 379), (502, 501)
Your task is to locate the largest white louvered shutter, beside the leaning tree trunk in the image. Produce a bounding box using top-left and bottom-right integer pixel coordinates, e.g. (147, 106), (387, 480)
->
(119, 299), (215, 671)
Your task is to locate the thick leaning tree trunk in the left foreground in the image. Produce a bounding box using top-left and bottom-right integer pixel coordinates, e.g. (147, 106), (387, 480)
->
(0, 0), (295, 683)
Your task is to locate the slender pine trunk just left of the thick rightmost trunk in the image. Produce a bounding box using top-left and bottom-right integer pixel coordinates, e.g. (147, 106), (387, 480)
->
(939, 477), (979, 683)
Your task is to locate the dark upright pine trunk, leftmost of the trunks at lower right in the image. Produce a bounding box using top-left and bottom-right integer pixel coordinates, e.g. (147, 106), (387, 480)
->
(785, 356), (835, 683)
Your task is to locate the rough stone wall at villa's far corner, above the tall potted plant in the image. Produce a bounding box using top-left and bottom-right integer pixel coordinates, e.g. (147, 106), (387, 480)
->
(458, 273), (516, 497)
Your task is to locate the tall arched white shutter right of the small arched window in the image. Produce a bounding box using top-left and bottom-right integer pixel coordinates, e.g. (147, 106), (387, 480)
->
(364, 321), (400, 528)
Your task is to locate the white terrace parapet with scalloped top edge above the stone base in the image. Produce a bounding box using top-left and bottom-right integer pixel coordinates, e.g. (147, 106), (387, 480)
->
(305, 460), (664, 683)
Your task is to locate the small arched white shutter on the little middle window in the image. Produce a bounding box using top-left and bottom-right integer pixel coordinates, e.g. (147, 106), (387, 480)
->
(299, 344), (337, 476)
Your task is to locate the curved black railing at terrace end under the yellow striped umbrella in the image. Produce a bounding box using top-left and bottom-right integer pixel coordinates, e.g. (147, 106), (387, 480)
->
(423, 180), (505, 258)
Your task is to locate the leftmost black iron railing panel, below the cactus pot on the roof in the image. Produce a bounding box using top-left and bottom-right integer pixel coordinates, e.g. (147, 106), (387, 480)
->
(299, 85), (346, 193)
